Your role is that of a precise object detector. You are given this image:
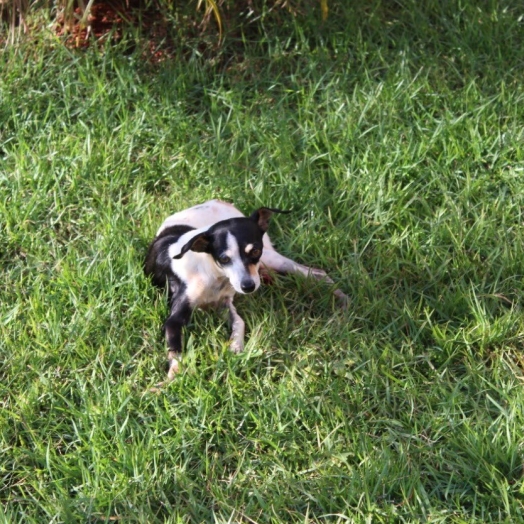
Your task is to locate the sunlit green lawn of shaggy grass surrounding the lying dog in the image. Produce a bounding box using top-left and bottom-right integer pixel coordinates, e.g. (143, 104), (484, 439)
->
(0, 0), (524, 523)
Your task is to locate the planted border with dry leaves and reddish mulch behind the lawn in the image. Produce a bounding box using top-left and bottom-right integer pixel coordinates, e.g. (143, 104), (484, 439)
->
(0, 0), (329, 46)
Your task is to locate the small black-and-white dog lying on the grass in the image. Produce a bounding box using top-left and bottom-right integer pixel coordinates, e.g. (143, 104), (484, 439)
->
(144, 200), (348, 380)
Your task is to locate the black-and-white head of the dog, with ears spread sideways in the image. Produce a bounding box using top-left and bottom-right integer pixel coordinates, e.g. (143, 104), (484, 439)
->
(174, 207), (285, 293)
